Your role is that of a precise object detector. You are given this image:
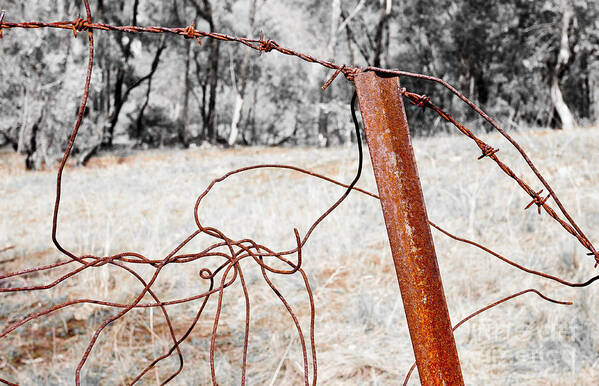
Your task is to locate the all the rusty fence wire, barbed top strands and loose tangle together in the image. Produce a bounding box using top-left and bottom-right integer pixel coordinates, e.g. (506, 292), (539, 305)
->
(0, 0), (599, 385)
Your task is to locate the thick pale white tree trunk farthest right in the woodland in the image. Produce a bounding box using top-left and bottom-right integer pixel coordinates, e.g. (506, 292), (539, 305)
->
(551, 0), (577, 130)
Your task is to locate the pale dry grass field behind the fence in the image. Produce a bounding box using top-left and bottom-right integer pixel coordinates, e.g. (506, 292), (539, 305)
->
(0, 128), (599, 385)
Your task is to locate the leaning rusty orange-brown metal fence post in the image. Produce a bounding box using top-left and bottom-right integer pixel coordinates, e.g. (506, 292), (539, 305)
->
(354, 72), (464, 385)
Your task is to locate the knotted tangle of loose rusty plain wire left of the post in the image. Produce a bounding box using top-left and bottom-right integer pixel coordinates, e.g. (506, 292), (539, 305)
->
(0, 43), (363, 384)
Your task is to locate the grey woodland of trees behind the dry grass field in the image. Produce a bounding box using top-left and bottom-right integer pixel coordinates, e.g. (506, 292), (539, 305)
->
(0, 0), (599, 169)
